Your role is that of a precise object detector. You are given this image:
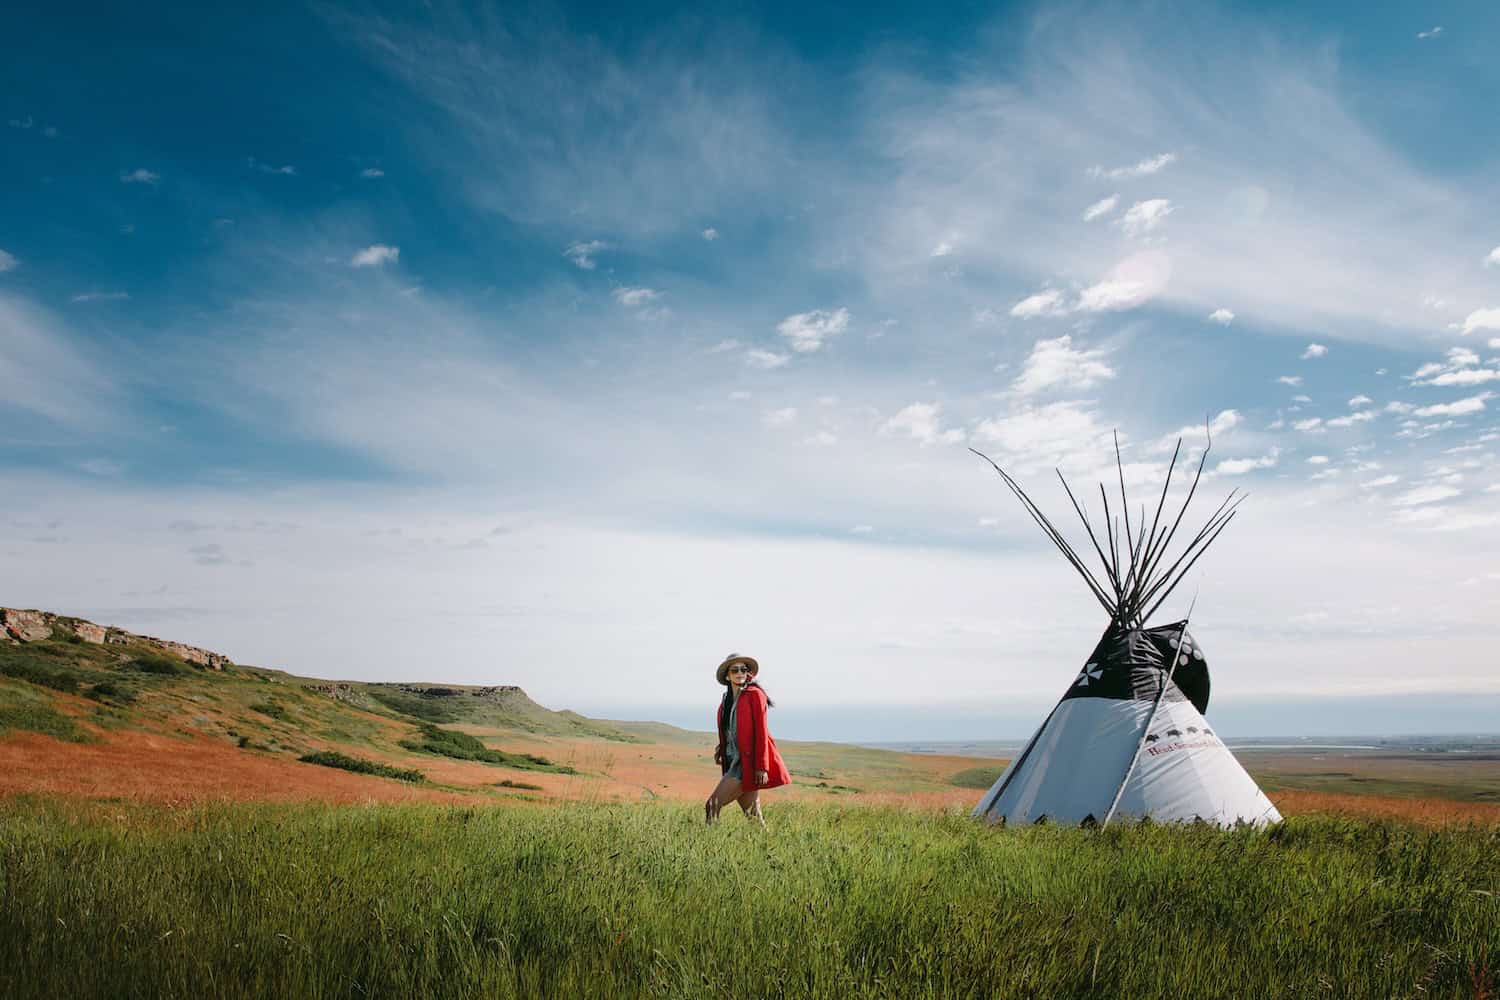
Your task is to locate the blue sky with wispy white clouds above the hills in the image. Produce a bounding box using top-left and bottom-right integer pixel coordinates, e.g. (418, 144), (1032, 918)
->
(0, 1), (1500, 741)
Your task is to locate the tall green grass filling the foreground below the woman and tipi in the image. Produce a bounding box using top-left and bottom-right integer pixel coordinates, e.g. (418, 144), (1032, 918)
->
(0, 801), (1500, 999)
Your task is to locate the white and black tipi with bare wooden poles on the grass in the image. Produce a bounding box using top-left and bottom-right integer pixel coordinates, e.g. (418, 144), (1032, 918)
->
(974, 438), (1281, 826)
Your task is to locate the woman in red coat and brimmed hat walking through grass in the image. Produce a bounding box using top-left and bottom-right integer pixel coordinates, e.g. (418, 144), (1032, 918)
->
(704, 655), (792, 826)
